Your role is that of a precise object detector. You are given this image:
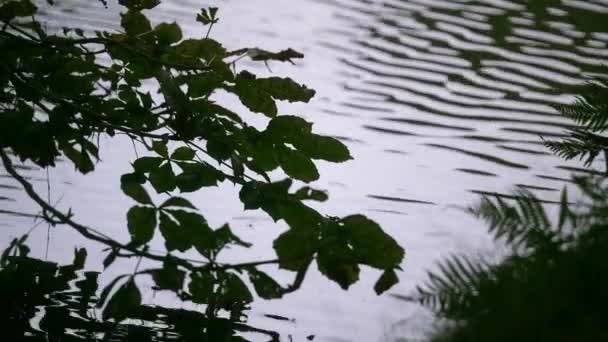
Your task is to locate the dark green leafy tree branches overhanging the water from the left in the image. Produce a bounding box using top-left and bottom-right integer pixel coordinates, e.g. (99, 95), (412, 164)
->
(0, 0), (404, 341)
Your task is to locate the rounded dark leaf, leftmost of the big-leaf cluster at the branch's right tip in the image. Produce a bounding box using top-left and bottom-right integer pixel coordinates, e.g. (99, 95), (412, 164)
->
(273, 229), (319, 271)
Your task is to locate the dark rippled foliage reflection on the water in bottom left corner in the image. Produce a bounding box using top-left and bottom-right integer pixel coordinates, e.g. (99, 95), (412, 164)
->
(0, 250), (279, 342)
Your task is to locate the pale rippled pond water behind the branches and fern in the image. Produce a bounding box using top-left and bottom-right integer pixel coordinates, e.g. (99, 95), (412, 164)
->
(0, 0), (608, 341)
